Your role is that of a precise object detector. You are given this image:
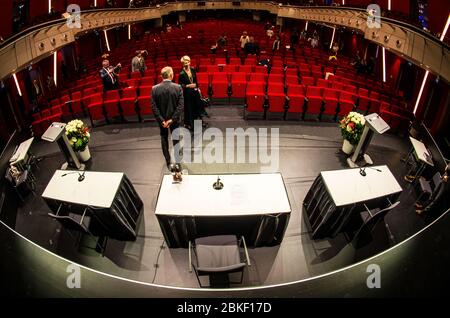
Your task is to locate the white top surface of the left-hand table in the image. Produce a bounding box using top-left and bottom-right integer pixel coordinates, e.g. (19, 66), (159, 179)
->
(42, 170), (123, 208)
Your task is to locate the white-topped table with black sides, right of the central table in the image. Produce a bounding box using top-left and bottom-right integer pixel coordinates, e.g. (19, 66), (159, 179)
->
(303, 165), (402, 239)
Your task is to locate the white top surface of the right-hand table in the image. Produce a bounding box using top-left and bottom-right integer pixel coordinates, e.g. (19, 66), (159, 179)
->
(321, 165), (402, 206)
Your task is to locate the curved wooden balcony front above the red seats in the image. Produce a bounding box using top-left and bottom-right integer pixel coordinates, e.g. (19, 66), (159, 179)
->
(0, 1), (450, 82)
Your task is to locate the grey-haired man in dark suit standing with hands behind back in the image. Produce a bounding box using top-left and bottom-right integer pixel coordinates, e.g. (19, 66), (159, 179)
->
(152, 66), (184, 169)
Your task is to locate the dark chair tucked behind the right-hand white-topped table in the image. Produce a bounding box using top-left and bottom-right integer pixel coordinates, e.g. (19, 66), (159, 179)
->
(352, 199), (400, 245)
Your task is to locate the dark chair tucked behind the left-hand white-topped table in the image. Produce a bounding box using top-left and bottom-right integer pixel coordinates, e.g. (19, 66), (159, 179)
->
(48, 204), (108, 256)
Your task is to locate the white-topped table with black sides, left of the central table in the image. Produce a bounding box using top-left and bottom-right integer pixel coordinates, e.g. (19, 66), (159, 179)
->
(42, 170), (143, 240)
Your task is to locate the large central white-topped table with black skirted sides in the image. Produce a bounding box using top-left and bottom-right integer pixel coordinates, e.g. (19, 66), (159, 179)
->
(155, 173), (291, 247)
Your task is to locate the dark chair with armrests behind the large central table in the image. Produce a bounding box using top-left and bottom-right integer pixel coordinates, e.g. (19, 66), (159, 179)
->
(189, 235), (250, 287)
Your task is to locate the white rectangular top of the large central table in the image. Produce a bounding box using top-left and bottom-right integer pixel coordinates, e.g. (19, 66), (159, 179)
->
(155, 173), (291, 216)
